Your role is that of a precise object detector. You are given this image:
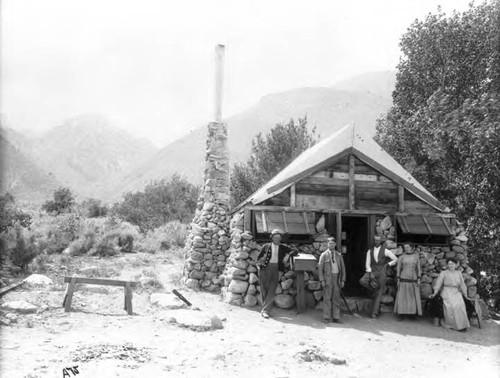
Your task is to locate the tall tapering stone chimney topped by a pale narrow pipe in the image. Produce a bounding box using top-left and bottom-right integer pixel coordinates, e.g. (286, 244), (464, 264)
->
(183, 45), (230, 291)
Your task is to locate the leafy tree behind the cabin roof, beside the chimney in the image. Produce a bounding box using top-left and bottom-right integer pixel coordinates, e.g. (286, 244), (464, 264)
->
(230, 117), (319, 207)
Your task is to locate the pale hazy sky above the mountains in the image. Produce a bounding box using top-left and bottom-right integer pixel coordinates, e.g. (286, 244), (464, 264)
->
(1, 0), (470, 145)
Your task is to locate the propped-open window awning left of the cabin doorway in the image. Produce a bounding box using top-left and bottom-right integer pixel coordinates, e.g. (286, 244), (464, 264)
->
(254, 210), (316, 235)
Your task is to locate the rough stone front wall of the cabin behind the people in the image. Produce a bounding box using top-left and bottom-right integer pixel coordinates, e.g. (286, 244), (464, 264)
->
(221, 213), (477, 312)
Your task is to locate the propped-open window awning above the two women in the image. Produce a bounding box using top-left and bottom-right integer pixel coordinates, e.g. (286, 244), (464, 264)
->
(396, 215), (453, 236)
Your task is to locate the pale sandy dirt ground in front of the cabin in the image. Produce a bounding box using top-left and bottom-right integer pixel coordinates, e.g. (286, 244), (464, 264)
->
(0, 251), (500, 378)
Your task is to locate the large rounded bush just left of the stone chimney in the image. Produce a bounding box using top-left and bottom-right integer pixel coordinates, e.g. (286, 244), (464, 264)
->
(113, 175), (198, 232)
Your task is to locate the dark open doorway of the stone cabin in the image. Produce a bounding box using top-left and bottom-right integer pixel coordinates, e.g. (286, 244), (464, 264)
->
(342, 215), (368, 297)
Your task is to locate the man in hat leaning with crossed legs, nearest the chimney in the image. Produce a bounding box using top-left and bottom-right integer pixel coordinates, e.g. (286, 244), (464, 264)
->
(257, 229), (297, 319)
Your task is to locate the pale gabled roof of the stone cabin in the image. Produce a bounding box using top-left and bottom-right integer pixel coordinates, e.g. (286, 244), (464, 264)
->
(235, 125), (445, 211)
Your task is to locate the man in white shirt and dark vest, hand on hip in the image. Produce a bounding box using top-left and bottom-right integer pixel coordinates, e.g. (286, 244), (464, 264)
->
(359, 235), (398, 318)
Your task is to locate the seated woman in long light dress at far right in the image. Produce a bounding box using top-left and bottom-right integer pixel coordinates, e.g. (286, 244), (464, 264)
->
(431, 259), (470, 331)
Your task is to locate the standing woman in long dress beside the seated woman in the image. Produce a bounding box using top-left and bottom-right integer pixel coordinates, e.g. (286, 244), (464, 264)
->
(394, 244), (422, 320)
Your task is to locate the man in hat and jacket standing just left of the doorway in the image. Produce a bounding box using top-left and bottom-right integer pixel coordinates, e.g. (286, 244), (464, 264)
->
(318, 237), (346, 323)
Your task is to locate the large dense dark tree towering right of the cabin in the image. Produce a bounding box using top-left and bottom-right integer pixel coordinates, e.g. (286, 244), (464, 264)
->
(377, 2), (500, 294)
